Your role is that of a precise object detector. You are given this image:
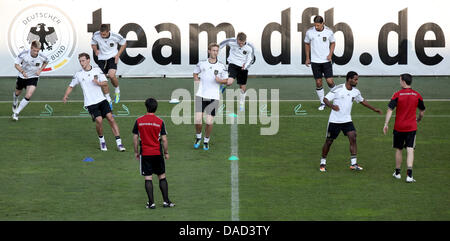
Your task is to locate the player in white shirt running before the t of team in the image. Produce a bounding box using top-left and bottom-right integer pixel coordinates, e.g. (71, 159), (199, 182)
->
(91, 24), (127, 108)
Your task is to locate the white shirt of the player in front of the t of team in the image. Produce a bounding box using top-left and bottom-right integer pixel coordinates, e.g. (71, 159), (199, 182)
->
(91, 31), (127, 60)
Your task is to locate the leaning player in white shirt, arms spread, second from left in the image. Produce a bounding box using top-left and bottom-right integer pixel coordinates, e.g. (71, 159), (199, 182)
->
(63, 53), (125, 151)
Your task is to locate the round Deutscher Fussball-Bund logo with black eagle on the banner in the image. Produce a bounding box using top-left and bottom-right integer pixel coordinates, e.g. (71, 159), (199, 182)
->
(8, 4), (77, 72)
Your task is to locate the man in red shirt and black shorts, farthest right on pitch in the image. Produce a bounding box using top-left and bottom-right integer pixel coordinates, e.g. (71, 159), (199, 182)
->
(383, 74), (425, 183)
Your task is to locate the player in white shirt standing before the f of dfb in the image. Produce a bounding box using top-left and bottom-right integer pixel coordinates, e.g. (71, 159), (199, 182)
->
(304, 16), (336, 110)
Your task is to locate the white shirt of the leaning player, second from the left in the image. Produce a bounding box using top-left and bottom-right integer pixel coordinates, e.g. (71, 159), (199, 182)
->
(69, 67), (107, 106)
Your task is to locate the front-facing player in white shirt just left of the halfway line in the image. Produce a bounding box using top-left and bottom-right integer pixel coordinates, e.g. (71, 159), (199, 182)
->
(193, 43), (228, 151)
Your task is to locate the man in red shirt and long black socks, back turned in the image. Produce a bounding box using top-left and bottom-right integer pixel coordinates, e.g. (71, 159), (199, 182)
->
(133, 98), (175, 209)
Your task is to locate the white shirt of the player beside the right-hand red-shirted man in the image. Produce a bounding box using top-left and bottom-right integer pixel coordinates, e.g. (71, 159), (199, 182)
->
(325, 84), (364, 123)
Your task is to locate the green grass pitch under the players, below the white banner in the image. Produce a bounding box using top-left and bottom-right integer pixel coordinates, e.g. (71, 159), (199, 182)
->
(0, 76), (450, 221)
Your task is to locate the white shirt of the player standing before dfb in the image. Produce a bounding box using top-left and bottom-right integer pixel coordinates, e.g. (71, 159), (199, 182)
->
(305, 25), (336, 63)
